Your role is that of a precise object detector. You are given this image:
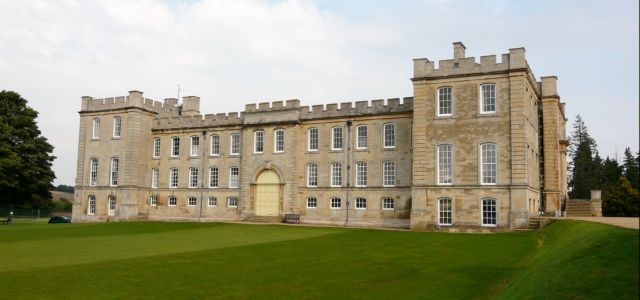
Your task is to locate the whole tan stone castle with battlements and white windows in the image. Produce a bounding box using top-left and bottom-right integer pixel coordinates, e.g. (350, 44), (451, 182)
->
(73, 42), (567, 231)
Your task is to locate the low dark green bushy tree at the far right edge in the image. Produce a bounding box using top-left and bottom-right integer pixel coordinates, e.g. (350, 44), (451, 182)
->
(602, 176), (640, 217)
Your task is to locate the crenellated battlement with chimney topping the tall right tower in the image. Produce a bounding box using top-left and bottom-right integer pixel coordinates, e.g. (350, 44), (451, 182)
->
(413, 42), (528, 79)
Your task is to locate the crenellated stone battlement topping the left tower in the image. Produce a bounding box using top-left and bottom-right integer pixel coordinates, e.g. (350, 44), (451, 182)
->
(80, 91), (178, 115)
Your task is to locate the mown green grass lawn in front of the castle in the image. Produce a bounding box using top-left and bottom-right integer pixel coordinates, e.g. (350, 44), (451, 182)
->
(0, 221), (638, 299)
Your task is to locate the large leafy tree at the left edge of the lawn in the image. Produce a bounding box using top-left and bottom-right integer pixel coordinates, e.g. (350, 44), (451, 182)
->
(0, 90), (55, 208)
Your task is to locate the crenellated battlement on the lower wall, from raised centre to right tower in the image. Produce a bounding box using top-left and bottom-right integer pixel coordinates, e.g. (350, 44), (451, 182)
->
(300, 97), (413, 120)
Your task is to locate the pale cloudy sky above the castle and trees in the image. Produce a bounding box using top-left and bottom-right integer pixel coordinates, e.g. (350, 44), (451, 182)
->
(0, 0), (639, 185)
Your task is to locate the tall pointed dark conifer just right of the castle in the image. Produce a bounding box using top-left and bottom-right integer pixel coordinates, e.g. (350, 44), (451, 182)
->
(569, 115), (602, 199)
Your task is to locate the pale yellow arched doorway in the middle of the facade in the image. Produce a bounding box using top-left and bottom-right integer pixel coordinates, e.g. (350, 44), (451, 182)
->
(256, 170), (280, 216)
